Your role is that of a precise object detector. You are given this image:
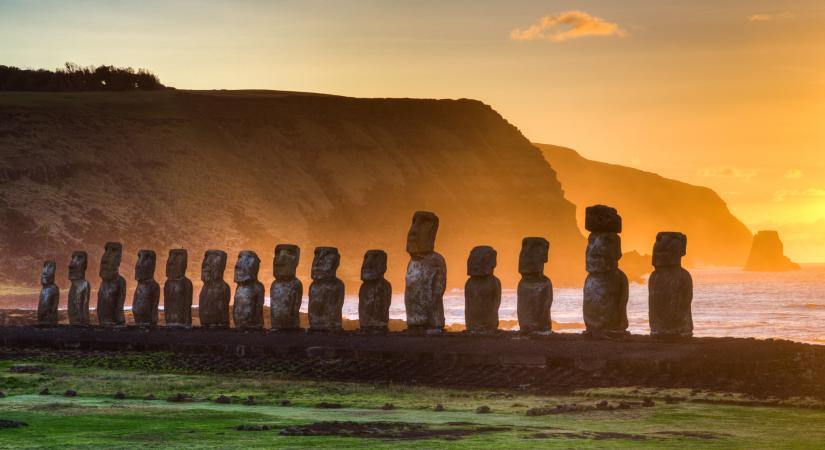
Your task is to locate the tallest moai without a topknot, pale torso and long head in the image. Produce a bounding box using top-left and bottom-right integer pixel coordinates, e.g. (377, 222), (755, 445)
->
(404, 211), (447, 332)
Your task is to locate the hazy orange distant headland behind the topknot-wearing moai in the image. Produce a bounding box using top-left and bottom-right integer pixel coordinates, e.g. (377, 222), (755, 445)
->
(536, 144), (752, 267)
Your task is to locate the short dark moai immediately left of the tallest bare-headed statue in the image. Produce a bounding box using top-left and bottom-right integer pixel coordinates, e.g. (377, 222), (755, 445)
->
(358, 250), (392, 333)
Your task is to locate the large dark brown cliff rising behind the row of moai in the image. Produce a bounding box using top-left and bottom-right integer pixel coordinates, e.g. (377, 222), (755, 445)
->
(0, 91), (584, 298)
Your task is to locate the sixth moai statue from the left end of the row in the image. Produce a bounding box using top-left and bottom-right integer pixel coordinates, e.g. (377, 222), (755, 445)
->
(198, 250), (231, 328)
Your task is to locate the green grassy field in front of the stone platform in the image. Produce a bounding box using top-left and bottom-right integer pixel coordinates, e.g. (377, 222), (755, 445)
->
(0, 355), (825, 448)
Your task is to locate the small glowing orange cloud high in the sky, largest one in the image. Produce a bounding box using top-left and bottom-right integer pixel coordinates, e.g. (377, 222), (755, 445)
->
(510, 10), (627, 42)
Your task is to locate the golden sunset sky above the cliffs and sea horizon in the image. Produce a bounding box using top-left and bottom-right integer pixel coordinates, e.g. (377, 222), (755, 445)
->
(0, 0), (825, 262)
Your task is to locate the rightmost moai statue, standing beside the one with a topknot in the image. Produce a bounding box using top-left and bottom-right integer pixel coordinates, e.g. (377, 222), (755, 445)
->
(647, 232), (693, 337)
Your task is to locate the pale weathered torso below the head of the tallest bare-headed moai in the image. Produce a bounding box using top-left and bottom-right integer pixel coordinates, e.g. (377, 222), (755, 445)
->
(404, 252), (447, 329)
